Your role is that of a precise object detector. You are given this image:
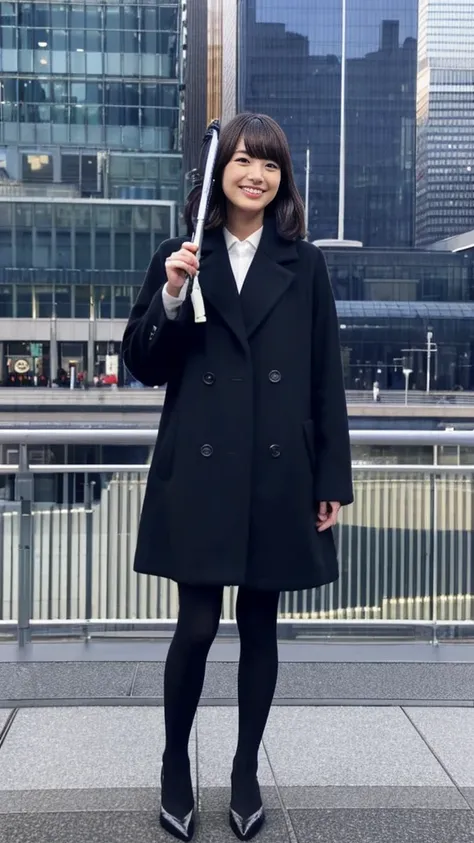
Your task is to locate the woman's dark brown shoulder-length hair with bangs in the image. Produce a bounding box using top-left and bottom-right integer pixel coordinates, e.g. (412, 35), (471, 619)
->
(184, 113), (306, 240)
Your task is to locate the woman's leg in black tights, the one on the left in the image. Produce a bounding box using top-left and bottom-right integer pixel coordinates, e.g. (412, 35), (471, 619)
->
(162, 584), (223, 817)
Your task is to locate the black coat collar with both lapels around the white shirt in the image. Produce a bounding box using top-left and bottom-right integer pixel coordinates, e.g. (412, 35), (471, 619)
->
(199, 218), (298, 349)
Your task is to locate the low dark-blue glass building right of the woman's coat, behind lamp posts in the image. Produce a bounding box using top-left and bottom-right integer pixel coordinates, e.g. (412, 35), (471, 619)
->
(324, 248), (474, 390)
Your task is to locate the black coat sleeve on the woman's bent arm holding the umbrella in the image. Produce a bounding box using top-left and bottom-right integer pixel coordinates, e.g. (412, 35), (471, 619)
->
(122, 243), (192, 386)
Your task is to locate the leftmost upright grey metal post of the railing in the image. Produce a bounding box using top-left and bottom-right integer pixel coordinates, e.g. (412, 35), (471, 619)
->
(15, 444), (34, 647)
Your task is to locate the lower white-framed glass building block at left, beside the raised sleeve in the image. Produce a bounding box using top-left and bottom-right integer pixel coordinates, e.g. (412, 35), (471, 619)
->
(0, 197), (177, 385)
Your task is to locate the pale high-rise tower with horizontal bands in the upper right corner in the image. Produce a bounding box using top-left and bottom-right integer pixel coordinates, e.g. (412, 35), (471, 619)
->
(416, 0), (474, 245)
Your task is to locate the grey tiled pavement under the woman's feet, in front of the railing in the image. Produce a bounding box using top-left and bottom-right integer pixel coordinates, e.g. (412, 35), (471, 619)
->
(0, 645), (474, 843)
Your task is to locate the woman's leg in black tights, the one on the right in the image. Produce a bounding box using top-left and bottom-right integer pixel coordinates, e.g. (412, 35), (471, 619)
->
(232, 588), (280, 818)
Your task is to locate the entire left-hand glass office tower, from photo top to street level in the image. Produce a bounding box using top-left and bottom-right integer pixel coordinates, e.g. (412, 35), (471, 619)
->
(0, 0), (184, 383)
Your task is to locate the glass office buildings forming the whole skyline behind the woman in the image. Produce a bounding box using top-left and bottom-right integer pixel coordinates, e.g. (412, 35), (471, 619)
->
(0, 0), (474, 390)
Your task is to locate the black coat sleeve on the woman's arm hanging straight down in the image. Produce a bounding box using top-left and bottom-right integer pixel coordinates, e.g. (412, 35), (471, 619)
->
(312, 249), (354, 506)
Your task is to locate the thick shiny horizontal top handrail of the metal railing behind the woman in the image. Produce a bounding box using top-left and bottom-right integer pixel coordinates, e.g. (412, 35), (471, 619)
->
(0, 428), (474, 447)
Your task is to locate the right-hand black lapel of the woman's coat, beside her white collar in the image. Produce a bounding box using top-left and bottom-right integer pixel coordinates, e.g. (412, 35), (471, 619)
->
(240, 218), (298, 339)
